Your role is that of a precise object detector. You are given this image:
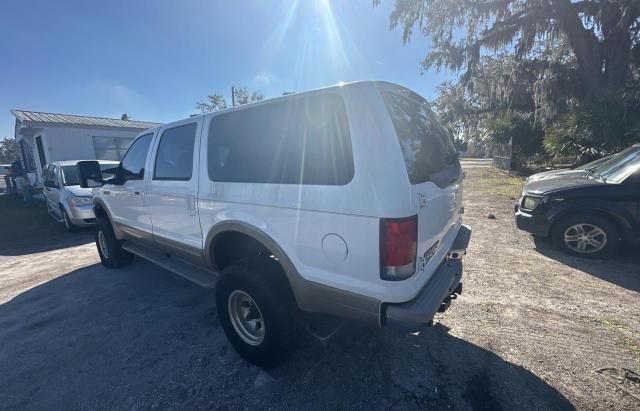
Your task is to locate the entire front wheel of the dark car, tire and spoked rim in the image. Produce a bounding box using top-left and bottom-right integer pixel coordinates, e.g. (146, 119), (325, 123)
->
(552, 214), (620, 258)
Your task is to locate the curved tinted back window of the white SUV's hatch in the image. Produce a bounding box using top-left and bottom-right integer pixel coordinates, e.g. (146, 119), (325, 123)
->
(380, 85), (460, 187)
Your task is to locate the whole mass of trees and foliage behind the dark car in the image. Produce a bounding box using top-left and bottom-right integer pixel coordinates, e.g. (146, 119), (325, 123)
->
(380, 0), (640, 162)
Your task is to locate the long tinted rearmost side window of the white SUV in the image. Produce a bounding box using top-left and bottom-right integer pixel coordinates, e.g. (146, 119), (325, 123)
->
(208, 94), (353, 185)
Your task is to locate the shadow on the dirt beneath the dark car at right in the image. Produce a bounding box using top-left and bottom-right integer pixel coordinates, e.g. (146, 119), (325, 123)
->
(534, 238), (640, 292)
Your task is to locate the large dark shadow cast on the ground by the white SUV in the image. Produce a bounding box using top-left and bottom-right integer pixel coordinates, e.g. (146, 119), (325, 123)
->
(0, 261), (572, 409)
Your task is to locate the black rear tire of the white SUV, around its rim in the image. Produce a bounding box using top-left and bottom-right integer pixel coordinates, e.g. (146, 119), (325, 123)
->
(216, 257), (299, 368)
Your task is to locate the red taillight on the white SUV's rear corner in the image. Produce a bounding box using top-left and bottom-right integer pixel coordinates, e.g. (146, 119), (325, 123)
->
(380, 215), (418, 281)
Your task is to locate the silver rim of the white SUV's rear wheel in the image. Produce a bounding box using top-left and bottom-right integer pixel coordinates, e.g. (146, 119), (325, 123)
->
(227, 290), (265, 346)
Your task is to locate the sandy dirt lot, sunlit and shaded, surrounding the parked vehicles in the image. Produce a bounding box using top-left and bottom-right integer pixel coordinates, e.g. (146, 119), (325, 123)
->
(0, 167), (640, 410)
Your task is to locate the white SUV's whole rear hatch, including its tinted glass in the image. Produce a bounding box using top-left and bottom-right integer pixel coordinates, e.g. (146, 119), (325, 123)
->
(379, 84), (462, 279)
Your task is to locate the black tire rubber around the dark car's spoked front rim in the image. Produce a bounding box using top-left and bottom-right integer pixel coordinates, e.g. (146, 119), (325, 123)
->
(551, 214), (620, 258)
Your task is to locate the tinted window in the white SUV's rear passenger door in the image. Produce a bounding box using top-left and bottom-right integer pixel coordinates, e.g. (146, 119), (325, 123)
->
(153, 123), (198, 181)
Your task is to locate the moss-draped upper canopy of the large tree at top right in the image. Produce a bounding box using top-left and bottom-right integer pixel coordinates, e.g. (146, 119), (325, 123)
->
(380, 0), (640, 99)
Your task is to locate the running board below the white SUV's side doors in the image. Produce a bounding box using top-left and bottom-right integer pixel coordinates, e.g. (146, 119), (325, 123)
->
(122, 241), (218, 288)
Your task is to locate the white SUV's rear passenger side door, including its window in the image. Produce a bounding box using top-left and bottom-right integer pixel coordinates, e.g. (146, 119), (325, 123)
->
(147, 117), (202, 262)
